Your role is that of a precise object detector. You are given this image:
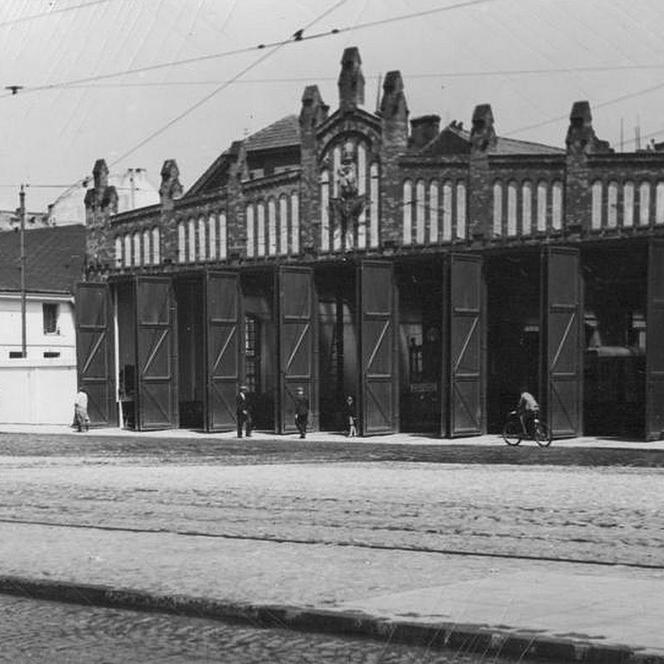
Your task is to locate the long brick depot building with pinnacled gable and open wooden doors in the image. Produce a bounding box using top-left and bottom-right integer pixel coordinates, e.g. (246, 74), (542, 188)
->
(77, 48), (664, 439)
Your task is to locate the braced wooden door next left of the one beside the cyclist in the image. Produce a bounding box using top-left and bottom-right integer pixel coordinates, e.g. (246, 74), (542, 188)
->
(441, 254), (486, 438)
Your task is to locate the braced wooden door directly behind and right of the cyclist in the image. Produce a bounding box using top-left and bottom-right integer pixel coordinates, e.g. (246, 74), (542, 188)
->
(541, 247), (583, 438)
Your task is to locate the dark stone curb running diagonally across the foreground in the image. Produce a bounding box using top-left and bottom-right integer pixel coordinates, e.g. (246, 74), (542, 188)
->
(0, 576), (664, 664)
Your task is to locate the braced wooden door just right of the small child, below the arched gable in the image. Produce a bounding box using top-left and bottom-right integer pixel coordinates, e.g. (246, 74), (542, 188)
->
(357, 261), (398, 435)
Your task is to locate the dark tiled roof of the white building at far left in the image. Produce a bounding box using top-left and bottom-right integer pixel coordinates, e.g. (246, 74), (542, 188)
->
(0, 225), (85, 293)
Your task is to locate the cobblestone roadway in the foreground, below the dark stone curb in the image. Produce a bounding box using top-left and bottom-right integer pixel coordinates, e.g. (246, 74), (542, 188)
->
(0, 595), (527, 664)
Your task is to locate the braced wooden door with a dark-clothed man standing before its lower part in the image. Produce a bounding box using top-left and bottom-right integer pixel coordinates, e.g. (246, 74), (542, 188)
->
(277, 265), (318, 433)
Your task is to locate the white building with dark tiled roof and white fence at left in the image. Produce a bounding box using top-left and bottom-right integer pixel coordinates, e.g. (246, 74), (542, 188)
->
(0, 225), (85, 424)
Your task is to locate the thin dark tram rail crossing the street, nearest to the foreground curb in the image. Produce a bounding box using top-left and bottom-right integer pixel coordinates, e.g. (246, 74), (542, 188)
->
(0, 518), (664, 570)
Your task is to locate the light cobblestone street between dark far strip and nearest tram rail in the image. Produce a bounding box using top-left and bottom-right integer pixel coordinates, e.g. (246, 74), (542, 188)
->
(0, 436), (664, 566)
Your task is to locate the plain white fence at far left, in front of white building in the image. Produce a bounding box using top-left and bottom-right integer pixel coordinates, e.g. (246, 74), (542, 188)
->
(0, 359), (76, 424)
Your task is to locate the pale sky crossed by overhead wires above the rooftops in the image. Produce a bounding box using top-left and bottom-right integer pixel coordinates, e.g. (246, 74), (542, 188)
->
(0, 0), (664, 211)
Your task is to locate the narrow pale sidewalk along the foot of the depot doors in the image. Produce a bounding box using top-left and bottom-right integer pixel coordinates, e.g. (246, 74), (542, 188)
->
(0, 423), (664, 450)
